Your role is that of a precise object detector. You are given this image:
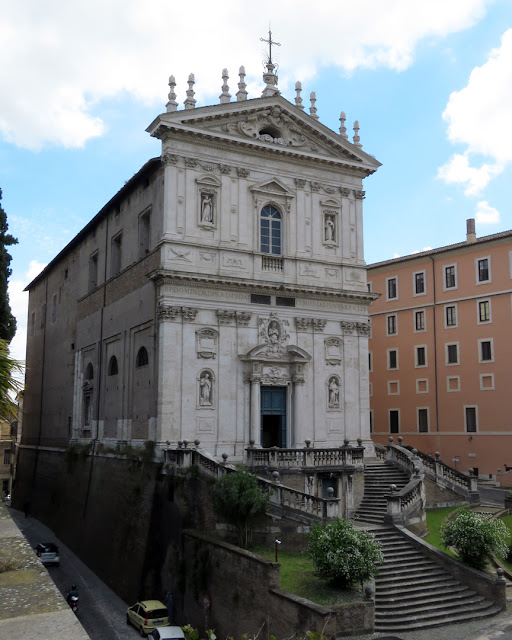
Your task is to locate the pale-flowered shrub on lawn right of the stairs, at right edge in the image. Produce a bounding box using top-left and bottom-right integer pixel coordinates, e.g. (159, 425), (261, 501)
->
(440, 507), (509, 569)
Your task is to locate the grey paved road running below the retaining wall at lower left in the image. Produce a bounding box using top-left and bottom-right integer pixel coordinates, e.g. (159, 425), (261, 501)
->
(10, 509), (139, 640)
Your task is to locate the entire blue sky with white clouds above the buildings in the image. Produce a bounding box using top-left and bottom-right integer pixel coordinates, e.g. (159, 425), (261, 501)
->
(0, 0), (512, 360)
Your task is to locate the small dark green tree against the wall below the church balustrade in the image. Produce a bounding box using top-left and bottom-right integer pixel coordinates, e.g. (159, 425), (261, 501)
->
(213, 469), (270, 549)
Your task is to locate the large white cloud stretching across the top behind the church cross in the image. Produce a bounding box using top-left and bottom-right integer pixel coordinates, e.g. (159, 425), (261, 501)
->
(0, 0), (492, 150)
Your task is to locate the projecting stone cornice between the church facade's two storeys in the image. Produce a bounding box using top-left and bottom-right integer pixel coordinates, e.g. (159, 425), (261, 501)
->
(148, 269), (379, 305)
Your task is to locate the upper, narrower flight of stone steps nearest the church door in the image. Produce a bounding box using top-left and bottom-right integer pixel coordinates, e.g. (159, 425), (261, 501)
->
(354, 460), (409, 524)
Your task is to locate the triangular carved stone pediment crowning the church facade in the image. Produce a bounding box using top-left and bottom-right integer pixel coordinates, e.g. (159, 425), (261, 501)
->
(147, 95), (380, 173)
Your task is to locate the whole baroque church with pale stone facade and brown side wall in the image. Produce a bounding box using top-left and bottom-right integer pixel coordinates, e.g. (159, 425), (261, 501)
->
(23, 51), (380, 460)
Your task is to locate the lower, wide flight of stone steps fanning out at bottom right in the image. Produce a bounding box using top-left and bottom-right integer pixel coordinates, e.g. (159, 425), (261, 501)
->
(368, 526), (500, 632)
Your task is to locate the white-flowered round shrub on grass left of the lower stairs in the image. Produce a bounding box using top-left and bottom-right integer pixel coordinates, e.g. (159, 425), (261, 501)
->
(308, 518), (384, 588)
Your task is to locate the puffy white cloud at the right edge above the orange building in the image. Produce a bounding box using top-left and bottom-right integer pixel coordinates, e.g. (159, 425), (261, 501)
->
(438, 29), (512, 195)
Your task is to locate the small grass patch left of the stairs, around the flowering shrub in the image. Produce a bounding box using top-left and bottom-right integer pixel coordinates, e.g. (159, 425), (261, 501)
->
(251, 547), (363, 607)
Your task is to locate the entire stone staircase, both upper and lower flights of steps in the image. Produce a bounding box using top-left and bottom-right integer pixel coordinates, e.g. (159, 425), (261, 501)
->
(355, 461), (500, 632)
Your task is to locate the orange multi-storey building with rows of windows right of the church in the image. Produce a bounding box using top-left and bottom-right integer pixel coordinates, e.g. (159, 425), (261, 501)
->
(368, 219), (512, 485)
